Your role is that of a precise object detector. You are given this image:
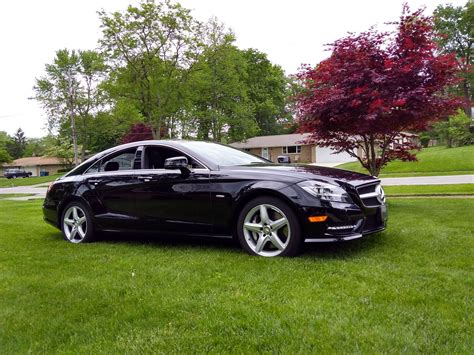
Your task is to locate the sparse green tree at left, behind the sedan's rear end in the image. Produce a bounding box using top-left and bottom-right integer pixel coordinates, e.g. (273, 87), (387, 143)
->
(34, 49), (104, 165)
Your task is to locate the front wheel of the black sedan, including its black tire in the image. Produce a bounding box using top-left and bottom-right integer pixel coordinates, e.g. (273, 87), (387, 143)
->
(237, 196), (303, 257)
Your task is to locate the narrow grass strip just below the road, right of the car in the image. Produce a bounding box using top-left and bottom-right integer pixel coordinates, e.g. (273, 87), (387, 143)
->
(383, 184), (474, 196)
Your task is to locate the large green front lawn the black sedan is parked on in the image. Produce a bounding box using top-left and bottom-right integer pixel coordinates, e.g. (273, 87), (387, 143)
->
(0, 198), (474, 354)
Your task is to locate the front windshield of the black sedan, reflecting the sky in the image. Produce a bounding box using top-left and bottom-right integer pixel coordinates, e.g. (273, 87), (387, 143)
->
(185, 142), (269, 166)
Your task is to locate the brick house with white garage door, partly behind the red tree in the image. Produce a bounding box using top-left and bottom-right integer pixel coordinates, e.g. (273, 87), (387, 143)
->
(231, 133), (356, 164)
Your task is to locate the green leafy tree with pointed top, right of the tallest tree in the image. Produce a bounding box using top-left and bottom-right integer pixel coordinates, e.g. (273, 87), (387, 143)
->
(193, 19), (258, 142)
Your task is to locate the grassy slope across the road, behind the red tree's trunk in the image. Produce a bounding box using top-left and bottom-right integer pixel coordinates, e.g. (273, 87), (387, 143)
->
(338, 145), (474, 177)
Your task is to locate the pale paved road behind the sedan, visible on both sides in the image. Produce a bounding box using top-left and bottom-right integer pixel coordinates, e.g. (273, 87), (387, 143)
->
(0, 175), (474, 200)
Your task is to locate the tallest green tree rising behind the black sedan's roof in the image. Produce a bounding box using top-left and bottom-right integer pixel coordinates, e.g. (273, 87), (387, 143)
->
(99, 0), (198, 139)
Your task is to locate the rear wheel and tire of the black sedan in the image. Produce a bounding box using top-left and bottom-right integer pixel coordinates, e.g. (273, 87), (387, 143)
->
(61, 201), (94, 244)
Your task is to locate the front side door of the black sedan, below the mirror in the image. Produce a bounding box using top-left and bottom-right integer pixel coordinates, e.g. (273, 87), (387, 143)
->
(135, 146), (213, 235)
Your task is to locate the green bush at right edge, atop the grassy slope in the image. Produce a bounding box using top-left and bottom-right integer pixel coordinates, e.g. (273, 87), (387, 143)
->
(434, 110), (473, 148)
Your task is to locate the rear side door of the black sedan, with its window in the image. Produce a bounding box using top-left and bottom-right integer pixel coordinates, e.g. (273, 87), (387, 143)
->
(85, 147), (143, 230)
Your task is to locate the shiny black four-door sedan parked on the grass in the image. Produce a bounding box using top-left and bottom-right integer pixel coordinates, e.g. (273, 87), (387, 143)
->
(43, 140), (387, 256)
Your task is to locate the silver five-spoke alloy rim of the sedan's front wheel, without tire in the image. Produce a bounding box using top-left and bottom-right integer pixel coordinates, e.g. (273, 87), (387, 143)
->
(243, 204), (291, 256)
